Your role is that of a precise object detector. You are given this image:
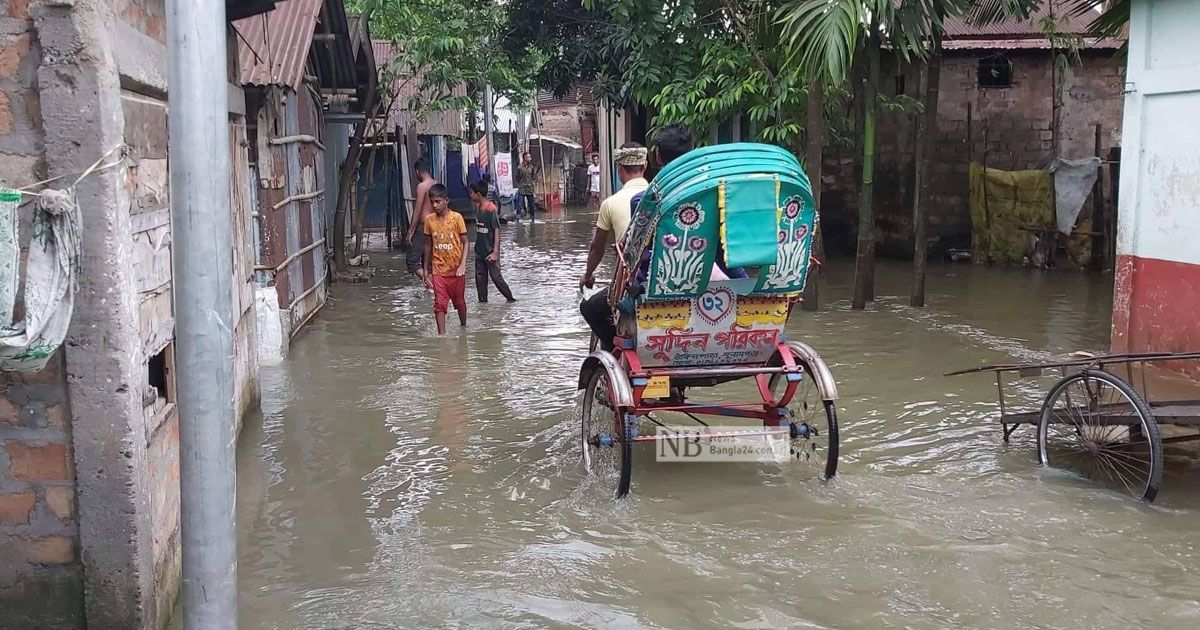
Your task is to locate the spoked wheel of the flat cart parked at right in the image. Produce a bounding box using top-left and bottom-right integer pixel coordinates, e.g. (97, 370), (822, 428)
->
(1038, 370), (1163, 502)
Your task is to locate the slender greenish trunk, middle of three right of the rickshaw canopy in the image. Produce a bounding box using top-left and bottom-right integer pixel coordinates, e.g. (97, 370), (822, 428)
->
(851, 30), (880, 311)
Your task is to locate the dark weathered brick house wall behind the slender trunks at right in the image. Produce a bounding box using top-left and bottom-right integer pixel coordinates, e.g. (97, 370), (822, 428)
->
(822, 50), (1124, 257)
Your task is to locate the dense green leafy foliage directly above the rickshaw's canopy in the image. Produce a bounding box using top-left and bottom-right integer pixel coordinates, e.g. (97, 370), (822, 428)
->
(547, 0), (841, 148)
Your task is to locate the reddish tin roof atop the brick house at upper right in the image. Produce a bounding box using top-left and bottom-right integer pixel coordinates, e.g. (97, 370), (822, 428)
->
(943, 0), (1121, 50)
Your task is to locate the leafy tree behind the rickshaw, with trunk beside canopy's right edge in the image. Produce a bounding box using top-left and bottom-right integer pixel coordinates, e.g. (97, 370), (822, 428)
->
(510, 0), (851, 308)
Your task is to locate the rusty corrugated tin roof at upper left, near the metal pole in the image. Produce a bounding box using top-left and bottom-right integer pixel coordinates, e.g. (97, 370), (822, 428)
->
(233, 0), (324, 90)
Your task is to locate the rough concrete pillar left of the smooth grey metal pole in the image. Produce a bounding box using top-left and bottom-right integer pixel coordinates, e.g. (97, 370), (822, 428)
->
(31, 0), (157, 629)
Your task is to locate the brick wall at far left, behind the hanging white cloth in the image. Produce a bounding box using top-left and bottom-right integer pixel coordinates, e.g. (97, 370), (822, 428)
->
(0, 0), (83, 629)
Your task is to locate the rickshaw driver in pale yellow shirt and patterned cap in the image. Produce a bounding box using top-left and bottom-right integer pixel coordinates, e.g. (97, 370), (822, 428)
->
(580, 143), (650, 352)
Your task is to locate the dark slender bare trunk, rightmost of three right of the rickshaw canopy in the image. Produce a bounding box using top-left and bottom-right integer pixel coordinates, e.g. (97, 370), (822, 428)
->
(908, 40), (942, 306)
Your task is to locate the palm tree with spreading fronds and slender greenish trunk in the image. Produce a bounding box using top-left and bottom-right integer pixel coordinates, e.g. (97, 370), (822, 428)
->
(779, 0), (964, 308)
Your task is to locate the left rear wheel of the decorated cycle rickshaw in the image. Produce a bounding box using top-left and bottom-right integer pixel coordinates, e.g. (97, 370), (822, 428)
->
(580, 368), (634, 499)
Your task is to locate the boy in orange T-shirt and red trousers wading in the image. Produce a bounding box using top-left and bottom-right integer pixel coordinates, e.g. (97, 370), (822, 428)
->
(425, 184), (467, 335)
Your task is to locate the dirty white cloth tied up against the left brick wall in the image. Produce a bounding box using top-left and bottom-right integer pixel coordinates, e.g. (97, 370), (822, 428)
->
(0, 189), (82, 372)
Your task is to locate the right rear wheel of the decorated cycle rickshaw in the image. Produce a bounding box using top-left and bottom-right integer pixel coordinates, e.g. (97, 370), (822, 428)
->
(770, 361), (838, 479)
